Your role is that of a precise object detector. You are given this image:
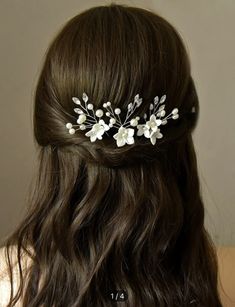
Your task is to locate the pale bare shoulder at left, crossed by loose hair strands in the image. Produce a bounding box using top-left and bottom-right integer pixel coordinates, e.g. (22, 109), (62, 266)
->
(0, 246), (30, 307)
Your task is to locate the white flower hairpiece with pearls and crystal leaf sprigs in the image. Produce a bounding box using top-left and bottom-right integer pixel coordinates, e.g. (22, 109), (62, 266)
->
(66, 93), (179, 147)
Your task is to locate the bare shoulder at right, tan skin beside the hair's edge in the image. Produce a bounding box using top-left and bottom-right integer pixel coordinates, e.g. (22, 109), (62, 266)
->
(217, 246), (235, 307)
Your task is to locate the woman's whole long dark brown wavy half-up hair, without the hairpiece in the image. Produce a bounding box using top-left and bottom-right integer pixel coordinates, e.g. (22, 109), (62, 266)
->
(1, 3), (222, 307)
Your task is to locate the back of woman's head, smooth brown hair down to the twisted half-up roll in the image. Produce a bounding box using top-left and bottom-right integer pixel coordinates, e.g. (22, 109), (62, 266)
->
(34, 1), (198, 166)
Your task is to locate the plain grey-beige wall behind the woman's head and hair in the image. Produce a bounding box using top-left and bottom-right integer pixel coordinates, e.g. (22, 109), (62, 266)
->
(0, 0), (235, 245)
